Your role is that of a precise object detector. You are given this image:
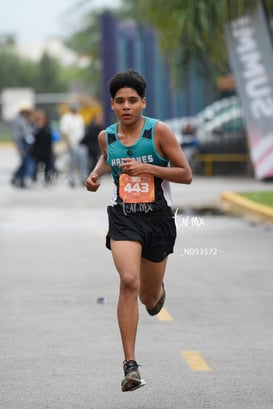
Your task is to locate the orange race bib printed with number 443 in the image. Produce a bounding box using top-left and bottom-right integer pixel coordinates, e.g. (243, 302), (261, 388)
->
(119, 173), (155, 203)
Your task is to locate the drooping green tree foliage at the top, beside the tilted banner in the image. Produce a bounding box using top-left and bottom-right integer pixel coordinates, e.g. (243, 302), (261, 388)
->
(120, 0), (273, 80)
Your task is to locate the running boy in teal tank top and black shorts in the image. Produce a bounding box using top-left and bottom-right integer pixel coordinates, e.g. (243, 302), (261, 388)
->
(86, 70), (192, 392)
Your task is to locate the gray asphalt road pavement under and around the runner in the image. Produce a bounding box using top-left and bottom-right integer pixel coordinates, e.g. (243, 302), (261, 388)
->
(0, 149), (273, 409)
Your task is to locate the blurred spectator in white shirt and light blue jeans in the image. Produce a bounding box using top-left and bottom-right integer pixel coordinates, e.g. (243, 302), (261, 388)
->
(60, 104), (88, 187)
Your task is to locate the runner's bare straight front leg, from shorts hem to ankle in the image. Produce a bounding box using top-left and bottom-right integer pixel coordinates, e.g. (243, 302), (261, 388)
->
(111, 239), (142, 361)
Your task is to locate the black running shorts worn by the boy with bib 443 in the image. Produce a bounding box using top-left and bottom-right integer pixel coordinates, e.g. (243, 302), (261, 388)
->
(106, 206), (176, 263)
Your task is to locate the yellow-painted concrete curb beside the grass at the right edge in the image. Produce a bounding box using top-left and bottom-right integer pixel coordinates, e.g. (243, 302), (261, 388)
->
(221, 192), (273, 222)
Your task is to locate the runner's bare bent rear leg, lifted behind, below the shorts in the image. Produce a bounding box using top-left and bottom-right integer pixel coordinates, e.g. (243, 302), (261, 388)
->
(140, 257), (168, 309)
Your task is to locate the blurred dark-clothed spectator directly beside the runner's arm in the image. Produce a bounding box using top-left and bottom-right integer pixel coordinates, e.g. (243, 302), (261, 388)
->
(81, 115), (104, 172)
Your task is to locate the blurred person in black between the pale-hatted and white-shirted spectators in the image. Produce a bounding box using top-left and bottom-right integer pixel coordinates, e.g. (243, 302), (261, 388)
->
(31, 110), (54, 183)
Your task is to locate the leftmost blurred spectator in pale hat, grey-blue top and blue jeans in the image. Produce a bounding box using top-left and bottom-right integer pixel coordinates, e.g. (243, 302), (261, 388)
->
(11, 102), (34, 188)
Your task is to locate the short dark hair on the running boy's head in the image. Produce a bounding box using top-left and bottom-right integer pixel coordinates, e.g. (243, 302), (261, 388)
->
(108, 69), (146, 98)
